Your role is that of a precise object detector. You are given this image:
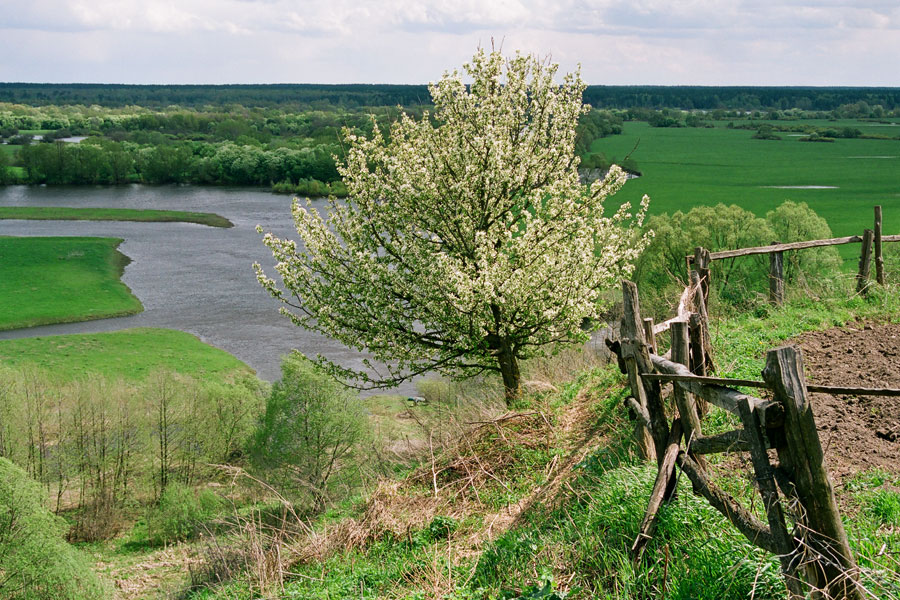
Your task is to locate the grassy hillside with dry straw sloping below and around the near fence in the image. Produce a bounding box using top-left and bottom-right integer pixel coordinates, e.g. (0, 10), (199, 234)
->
(98, 290), (900, 599)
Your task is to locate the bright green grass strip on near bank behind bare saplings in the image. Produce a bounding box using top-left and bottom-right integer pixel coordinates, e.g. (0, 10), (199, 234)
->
(0, 328), (251, 381)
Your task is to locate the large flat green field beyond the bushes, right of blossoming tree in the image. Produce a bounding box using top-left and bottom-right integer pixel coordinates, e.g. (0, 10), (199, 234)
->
(592, 120), (900, 256)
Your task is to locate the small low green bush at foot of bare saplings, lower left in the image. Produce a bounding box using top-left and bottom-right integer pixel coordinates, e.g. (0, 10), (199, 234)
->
(147, 483), (223, 545)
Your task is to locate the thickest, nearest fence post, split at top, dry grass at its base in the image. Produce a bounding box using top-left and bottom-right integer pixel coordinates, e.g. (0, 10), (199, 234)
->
(763, 344), (871, 600)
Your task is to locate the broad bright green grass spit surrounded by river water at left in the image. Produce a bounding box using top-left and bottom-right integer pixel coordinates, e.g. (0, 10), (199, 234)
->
(0, 236), (144, 330)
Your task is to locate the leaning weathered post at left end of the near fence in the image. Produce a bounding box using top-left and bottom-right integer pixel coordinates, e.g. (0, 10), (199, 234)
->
(620, 281), (669, 462)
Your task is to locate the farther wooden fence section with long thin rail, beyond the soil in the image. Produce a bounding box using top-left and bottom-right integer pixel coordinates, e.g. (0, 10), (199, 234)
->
(685, 206), (900, 305)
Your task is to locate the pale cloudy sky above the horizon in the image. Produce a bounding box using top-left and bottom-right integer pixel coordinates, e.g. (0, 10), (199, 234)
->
(0, 0), (900, 87)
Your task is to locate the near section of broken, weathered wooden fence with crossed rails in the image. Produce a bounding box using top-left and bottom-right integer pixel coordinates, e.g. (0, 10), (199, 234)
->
(607, 274), (900, 600)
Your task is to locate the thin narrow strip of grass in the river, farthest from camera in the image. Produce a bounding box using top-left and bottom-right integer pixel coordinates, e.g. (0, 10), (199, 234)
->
(0, 206), (234, 228)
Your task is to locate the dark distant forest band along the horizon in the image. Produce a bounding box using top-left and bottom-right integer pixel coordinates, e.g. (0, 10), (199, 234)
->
(0, 83), (900, 111)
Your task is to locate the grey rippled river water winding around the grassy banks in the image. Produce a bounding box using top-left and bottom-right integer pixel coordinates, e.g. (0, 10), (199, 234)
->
(0, 185), (414, 394)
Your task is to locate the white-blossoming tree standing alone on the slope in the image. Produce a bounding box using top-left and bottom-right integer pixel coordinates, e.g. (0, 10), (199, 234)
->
(255, 50), (647, 399)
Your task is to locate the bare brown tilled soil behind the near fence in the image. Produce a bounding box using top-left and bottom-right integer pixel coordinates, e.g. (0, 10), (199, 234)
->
(795, 324), (900, 484)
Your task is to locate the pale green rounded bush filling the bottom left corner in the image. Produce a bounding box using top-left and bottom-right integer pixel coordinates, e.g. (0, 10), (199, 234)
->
(0, 458), (107, 600)
